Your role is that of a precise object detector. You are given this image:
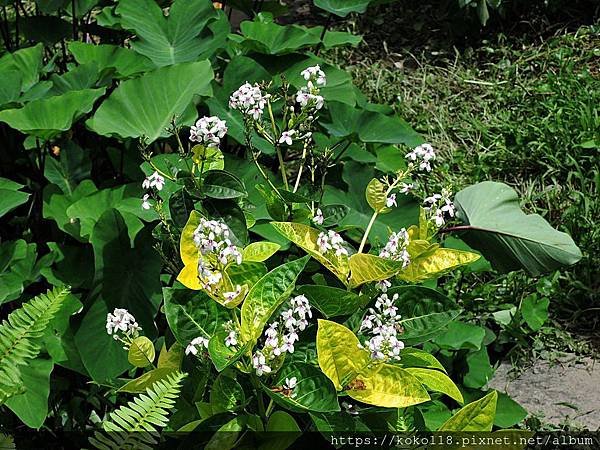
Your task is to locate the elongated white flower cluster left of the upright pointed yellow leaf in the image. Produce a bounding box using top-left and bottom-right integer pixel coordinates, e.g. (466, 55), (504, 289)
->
(253, 295), (312, 376)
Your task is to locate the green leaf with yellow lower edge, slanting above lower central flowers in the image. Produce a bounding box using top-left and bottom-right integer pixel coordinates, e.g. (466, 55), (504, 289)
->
(240, 256), (309, 342)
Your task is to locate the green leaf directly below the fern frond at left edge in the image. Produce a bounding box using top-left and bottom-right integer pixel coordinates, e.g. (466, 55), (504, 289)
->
(5, 358), (54, 428)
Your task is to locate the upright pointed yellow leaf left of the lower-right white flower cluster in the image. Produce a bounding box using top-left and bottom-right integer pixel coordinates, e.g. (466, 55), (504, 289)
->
(317, 319), (370, 391)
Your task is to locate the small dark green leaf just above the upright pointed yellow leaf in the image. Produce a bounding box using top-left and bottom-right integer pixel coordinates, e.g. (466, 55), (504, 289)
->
(298, 285), (362, 318)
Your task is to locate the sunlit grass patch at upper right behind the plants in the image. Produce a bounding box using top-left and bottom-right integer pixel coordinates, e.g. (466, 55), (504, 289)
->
(327, 25), (600, 354)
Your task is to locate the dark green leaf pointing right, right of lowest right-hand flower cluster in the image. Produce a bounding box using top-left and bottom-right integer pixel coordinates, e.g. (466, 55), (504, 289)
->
(388, 286), (461, 345)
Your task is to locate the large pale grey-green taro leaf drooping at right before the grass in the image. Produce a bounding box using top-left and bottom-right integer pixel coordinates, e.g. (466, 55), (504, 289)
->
(454, 181), (581, 276)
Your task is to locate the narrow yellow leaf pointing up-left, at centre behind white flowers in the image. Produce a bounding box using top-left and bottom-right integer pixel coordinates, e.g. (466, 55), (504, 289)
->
(271, 222), (350, 284)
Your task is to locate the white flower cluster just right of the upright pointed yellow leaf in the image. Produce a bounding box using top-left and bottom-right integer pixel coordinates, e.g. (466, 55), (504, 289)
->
(360, 293), (404, 361)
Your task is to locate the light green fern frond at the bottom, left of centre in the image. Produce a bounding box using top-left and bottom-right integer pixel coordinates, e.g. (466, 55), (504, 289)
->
(90, 372), (186, 450)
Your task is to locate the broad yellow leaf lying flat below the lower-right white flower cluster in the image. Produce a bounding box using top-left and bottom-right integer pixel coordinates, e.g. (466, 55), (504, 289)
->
(346, 364), (431, 408)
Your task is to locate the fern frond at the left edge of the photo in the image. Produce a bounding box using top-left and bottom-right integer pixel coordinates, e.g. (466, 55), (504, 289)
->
(0, 287), (69, 404)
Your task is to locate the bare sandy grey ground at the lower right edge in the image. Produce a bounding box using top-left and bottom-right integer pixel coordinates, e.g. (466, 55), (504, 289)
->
(490, 355), (600, 431)
